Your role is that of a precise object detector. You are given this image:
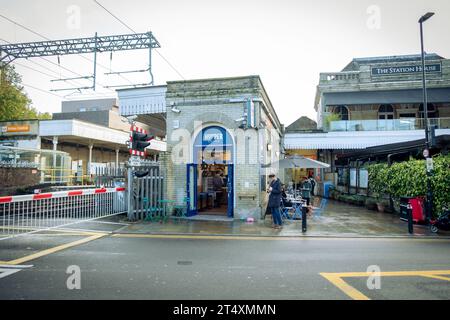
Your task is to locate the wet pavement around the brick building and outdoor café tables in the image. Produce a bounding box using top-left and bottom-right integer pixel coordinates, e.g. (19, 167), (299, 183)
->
(115, 198), (450, 237)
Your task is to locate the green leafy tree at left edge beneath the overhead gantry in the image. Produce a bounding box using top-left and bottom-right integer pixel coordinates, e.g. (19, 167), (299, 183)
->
(0, 66), (51, 121)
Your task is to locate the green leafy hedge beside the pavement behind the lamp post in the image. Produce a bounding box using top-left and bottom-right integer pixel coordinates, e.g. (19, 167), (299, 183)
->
(367, 155), (450, 214)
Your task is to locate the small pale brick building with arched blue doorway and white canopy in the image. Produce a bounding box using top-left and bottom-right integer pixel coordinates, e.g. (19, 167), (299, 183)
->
(118, 76), (283, 220)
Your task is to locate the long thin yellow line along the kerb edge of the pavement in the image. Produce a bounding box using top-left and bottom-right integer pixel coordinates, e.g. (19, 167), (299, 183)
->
(112, 233), (450, 242)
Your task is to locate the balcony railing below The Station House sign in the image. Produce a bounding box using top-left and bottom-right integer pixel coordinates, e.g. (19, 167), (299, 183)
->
(329, 118), (450, 131)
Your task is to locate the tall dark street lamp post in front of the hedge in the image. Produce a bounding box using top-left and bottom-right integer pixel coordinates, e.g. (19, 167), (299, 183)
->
(419, 12), (434, 220)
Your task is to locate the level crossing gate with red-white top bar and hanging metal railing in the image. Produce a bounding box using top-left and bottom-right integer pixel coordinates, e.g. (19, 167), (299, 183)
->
(0, 188), (127, 240)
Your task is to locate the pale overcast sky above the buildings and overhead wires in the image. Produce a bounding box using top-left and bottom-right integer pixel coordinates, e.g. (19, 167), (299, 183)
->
(0, 0), (450, 125)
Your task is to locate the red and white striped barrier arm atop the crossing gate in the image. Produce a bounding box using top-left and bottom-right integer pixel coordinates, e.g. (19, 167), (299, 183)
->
(0, 188), (126, 203)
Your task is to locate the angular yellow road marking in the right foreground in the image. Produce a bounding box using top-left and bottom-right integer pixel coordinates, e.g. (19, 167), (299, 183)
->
(320, 270), (450, 300)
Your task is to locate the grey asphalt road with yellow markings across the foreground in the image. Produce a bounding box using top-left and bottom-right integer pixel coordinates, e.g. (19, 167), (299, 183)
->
(0, 234), (450, 300)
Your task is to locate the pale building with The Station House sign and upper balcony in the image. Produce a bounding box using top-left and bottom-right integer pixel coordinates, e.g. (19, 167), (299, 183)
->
(284, 53), (450, 192)
